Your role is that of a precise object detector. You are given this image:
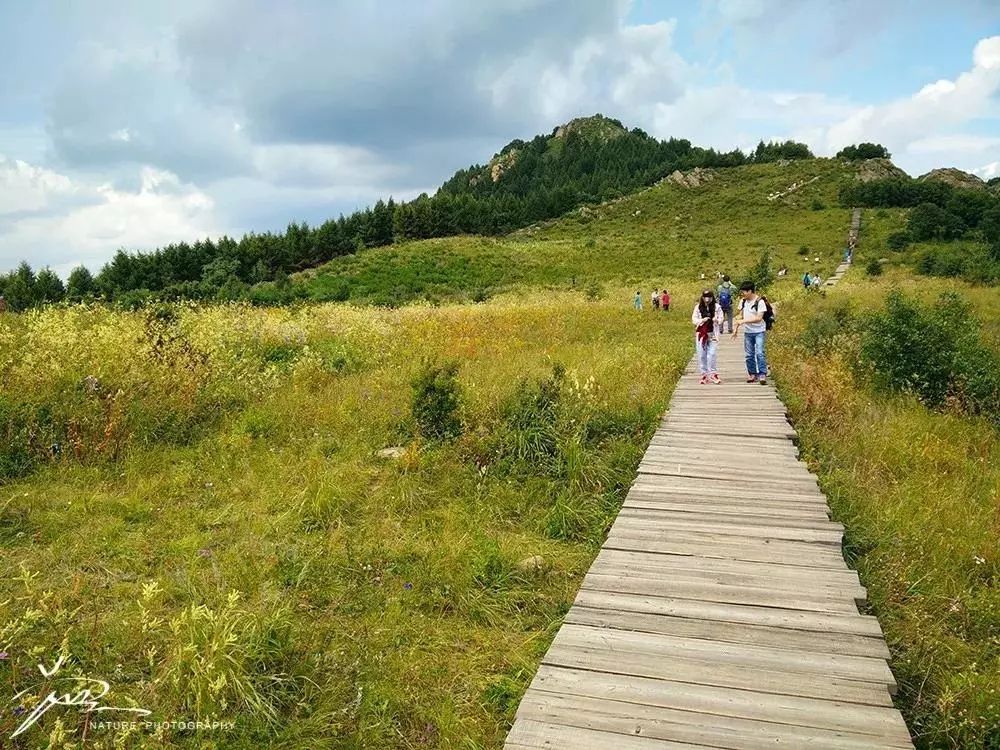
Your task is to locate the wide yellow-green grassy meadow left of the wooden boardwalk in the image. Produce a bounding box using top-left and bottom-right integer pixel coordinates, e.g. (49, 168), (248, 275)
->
(0, 293), (690, 748)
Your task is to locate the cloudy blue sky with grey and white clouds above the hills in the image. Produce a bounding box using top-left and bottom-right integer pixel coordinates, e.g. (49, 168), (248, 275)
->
(0, 0), (1000, 276)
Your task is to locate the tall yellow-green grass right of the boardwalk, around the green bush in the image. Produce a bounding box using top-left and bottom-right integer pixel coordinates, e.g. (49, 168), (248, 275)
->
(772, 276), (1000, 748)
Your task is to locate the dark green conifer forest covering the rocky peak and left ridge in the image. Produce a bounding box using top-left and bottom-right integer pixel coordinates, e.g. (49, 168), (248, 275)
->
(0, 123), (813, 310)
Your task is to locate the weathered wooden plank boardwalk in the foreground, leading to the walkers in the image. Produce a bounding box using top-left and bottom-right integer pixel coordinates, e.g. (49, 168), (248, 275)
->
(505, 328), (913, 750)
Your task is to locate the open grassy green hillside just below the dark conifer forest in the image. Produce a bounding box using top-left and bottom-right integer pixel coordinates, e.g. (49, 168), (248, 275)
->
(293, 159), (856, 305)
